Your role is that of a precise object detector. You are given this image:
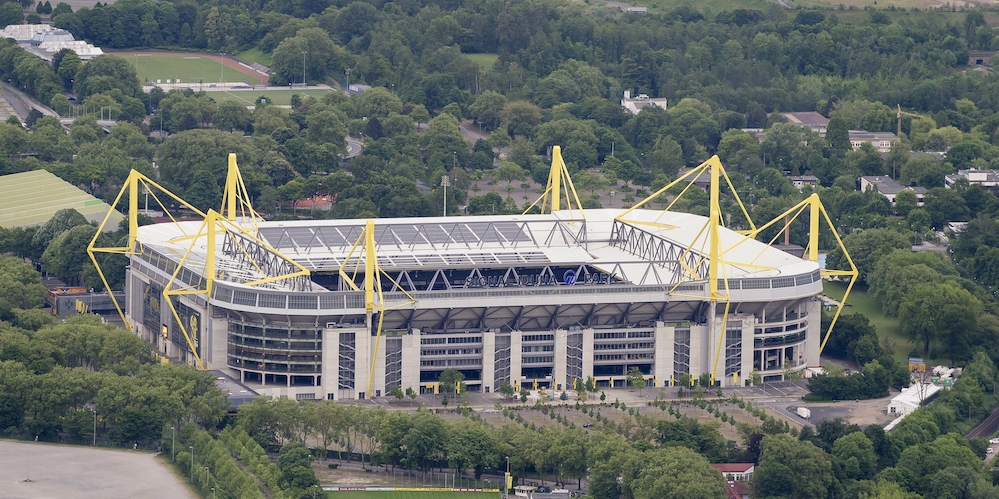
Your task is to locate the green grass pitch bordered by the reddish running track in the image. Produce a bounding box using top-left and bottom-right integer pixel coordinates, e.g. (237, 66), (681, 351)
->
(127, 53), (266, 84)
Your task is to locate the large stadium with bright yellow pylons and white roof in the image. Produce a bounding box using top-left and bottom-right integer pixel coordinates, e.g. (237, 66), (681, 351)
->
(89, 147), (856, 400)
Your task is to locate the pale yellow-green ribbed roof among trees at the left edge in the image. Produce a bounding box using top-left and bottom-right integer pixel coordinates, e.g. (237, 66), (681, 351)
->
(0, 170), (124, 230)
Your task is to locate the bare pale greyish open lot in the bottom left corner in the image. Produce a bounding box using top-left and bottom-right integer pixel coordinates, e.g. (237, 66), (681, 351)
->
(0, 440), (197, 499)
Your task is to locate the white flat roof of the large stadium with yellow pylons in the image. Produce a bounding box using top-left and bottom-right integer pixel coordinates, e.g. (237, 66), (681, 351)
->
(139, 209), (818, 292)
